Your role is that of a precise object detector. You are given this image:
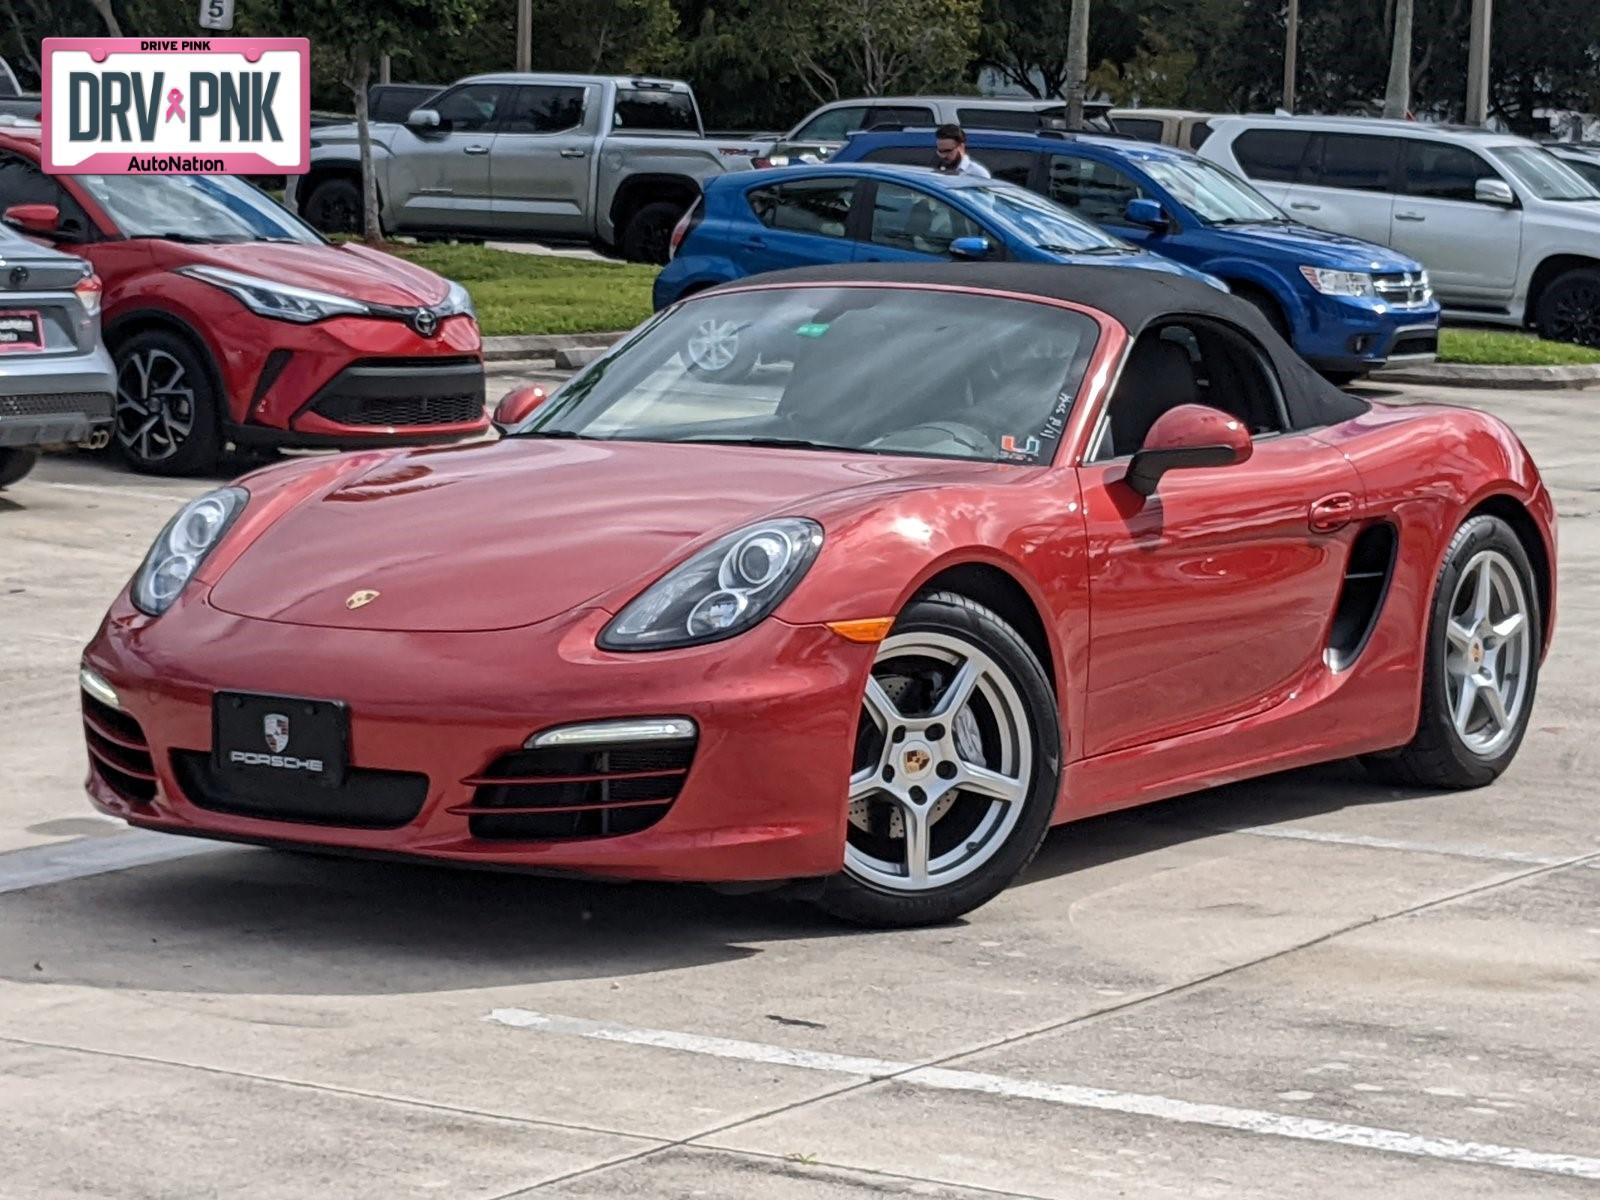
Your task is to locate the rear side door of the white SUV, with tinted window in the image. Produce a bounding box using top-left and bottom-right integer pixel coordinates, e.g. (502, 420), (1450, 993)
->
(1285, 133), (1400, 245)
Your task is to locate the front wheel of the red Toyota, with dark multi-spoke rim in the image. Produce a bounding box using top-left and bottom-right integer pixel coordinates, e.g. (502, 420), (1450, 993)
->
(112, 330), (222, 475)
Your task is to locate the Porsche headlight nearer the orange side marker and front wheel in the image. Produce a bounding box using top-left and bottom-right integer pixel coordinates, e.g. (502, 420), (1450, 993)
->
(600, 517), (822, 650)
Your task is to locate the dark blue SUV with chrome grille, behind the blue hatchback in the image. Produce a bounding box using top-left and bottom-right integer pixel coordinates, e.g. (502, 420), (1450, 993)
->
(829, 126), (1438, 382)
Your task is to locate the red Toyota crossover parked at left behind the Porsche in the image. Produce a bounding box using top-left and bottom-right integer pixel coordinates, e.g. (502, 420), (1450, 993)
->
(0, 126), (488, 475)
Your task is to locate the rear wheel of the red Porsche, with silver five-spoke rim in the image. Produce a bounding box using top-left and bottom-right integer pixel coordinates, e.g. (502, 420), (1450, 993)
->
(1365, 515), (1542, 789)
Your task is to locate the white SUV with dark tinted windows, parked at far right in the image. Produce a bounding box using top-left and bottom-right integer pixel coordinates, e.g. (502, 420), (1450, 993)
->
(1200, 117), (1600, 346)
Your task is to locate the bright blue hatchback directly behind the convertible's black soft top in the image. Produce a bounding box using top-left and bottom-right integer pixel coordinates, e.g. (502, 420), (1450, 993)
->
(654, 163), (1222, 309)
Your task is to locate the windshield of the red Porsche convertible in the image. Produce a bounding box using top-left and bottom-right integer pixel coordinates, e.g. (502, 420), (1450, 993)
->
(515, 286), (1098, 464)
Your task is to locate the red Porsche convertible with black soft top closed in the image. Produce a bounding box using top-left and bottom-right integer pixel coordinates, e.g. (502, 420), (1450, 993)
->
(82, 262), (1555, 925)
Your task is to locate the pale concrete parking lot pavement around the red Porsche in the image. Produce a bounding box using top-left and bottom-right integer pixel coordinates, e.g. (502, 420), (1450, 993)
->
(0, 377), (1600, 1200)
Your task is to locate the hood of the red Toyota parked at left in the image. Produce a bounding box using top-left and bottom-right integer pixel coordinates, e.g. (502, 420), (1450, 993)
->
(168, 242), (450, 307)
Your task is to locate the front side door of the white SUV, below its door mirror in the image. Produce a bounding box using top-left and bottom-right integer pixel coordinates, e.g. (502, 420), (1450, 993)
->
(1384, 138), (1523, 307)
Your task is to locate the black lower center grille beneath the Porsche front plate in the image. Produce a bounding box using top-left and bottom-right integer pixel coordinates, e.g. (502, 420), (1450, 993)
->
(173, 750), (427, 829)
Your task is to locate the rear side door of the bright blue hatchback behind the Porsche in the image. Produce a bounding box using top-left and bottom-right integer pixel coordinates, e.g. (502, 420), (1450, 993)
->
(733, 176), (856, 274)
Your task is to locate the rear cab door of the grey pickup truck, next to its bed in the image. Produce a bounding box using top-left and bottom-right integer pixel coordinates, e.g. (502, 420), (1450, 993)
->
(490, 83), (600, 235)
